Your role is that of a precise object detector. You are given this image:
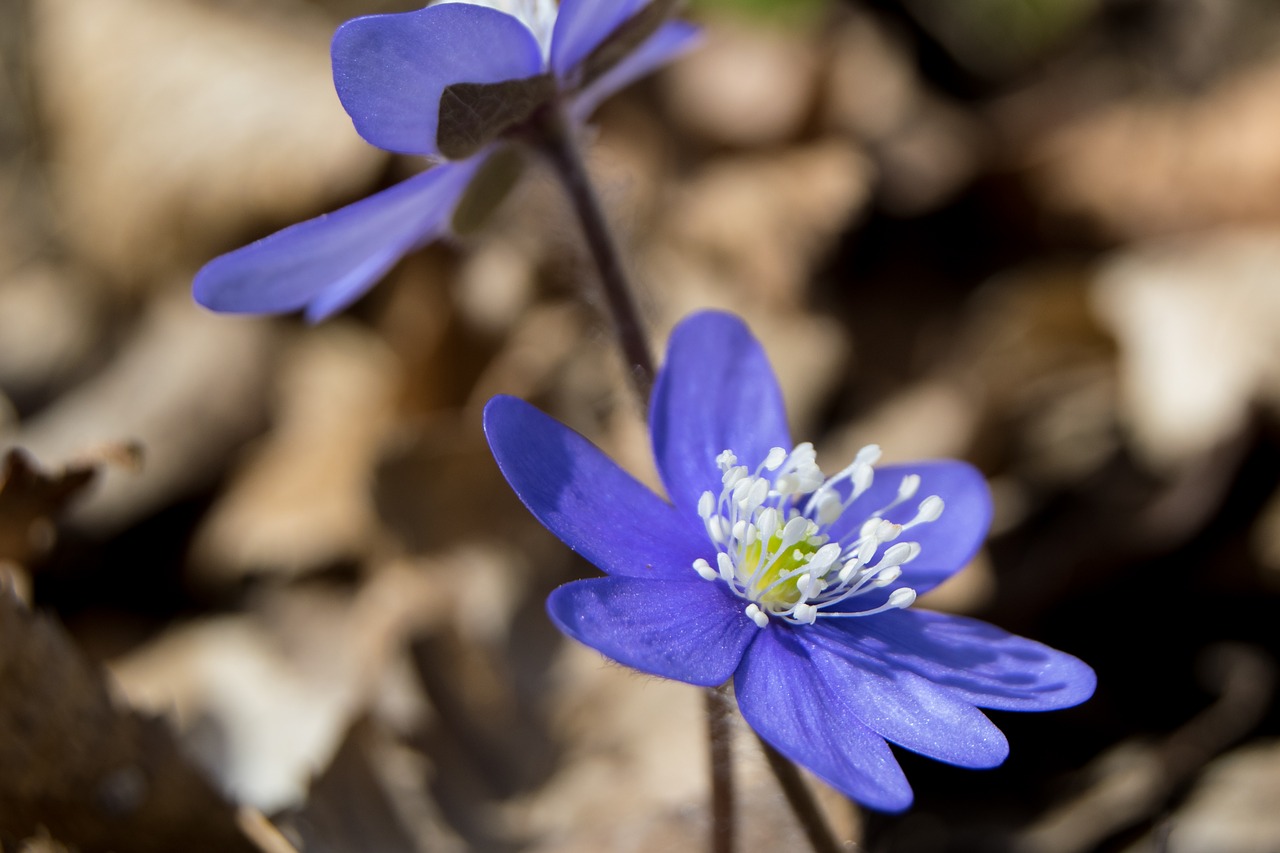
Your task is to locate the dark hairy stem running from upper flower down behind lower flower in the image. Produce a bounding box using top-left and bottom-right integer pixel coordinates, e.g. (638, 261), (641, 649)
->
(539, 113), (655, 399)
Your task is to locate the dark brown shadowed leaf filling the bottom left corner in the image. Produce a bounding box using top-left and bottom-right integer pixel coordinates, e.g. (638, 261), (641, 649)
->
(0, 590), (256, 853)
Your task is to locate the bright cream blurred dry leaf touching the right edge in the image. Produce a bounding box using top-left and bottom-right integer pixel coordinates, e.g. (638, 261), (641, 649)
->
(1092, 231), (1280, 469)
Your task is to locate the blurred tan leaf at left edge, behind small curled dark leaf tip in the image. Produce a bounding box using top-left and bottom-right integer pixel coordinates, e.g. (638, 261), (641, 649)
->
(0, 295), (274, 534)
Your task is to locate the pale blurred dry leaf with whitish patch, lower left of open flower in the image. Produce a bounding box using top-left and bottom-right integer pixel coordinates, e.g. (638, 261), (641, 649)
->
(111, 565), (458, 812)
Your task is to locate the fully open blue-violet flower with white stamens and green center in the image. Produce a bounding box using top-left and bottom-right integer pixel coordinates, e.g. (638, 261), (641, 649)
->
(484, 313), (1094, 811)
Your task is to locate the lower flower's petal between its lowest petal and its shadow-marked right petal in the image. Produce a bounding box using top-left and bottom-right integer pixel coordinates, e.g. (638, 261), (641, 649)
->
(792, 616), (1009, 767)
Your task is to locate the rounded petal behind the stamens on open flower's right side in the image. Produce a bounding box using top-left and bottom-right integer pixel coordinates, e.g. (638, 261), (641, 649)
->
(829, 460), (991, 596)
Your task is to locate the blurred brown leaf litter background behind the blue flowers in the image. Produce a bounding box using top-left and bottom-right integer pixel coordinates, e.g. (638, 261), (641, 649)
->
(0, 0), (1280, 853)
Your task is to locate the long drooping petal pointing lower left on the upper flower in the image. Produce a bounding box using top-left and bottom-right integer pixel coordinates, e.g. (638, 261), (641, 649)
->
(193, 158), (484, 320)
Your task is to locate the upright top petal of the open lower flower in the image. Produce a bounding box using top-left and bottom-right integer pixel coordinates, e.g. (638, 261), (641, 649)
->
(649, 311), (791, 517)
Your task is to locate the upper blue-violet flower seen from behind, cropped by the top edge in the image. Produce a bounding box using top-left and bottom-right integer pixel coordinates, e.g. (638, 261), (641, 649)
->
(195, 0), (696, 320)
